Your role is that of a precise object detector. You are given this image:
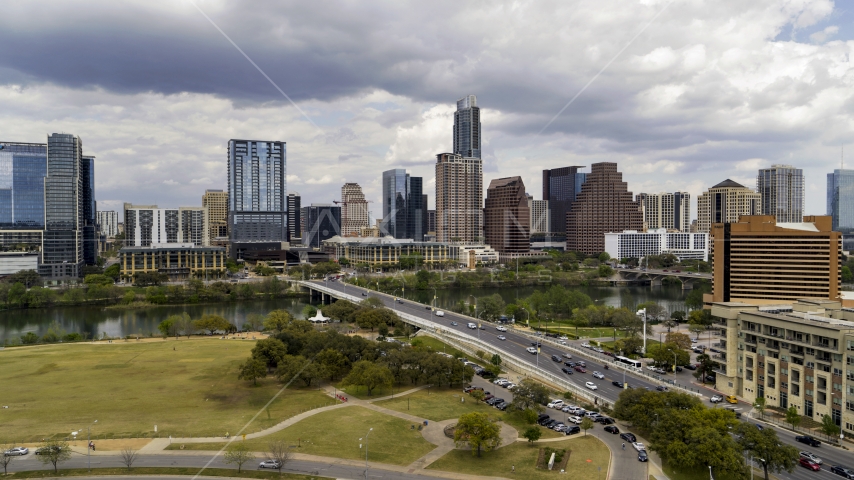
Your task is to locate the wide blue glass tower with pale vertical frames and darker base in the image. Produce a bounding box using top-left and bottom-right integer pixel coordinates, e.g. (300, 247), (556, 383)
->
(228, 140), (288, 242)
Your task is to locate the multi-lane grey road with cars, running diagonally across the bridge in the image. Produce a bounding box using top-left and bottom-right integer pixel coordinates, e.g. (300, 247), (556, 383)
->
(314, 281), (854, 480)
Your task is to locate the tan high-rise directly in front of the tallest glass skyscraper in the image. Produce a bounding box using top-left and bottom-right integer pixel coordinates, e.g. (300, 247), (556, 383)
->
(436, 153), (483, 243)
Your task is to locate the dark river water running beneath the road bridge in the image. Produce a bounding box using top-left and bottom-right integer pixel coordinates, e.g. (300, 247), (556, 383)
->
(0, 286), (690, 345)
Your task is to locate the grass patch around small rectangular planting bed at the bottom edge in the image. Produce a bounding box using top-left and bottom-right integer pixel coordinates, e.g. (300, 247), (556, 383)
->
(427, 435), (611, 480)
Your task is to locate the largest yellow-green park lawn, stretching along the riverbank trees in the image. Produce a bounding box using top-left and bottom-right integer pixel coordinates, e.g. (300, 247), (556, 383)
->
(0, 338), (332, 443)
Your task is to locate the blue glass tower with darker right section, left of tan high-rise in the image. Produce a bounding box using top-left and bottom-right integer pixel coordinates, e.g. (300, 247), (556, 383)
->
(381, 168), (425, 242)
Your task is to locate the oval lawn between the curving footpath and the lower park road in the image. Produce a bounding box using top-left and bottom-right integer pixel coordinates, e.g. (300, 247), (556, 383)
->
(169, 406), (436, 465)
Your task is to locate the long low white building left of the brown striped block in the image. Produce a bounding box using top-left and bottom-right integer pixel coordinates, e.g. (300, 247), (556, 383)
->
(605, 228), (709, 262)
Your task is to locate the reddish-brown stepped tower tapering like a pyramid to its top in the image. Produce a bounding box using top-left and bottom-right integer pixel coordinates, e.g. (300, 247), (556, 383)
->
(568, 162), (643, 255)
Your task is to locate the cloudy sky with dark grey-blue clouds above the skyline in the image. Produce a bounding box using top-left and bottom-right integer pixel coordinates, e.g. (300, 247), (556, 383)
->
(0, 0), (854, 219)
